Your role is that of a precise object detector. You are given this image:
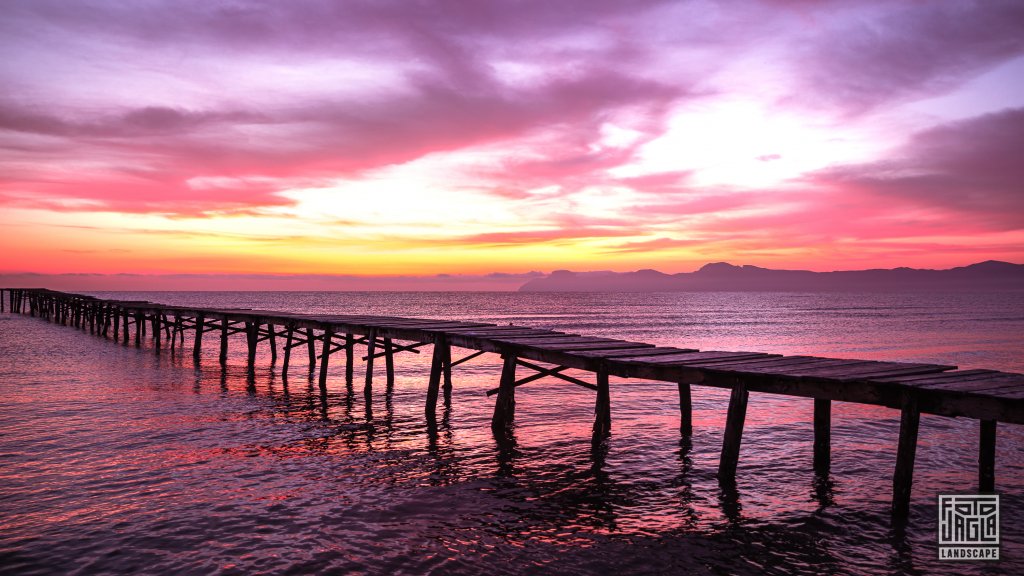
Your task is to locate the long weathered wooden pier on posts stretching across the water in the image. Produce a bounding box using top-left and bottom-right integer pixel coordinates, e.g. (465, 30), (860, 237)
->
(0, 289), (1024, 520)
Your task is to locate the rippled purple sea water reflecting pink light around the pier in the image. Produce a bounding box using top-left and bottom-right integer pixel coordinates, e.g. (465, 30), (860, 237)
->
(0, 292), (1024, 574)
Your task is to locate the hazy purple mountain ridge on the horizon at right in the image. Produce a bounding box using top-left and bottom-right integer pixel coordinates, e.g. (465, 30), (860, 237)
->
(519, 260), (1024, 292)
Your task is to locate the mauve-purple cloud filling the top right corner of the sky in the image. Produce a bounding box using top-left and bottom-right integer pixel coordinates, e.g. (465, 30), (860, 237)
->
(791, 0), (1024, 114)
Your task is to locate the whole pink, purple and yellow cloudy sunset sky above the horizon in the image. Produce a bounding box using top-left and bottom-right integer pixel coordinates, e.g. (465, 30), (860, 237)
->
(0, 0), (1024, 287)
